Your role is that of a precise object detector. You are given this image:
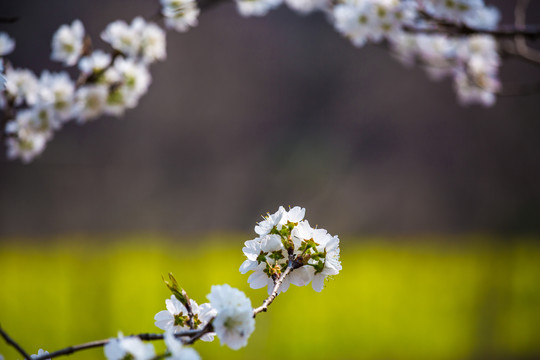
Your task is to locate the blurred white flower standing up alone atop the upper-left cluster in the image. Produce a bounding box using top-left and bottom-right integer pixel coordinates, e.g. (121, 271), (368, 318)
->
(51, 20), (84, 66)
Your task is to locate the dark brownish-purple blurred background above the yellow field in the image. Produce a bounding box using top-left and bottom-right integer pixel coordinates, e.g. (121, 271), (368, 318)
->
(0, 0), (540, 236)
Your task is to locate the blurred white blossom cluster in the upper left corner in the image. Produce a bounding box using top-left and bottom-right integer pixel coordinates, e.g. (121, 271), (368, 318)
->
(0, 17), (166, 162)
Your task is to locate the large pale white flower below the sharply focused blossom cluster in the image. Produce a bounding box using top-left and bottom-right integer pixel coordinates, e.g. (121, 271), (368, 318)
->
(207, 284), (255, 350)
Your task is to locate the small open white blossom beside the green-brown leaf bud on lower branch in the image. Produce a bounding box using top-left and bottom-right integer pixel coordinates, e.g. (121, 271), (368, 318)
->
(154, 295), (216, 341)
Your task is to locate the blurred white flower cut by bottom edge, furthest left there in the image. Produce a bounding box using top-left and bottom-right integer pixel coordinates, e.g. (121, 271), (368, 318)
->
(104, 333), (156, 360)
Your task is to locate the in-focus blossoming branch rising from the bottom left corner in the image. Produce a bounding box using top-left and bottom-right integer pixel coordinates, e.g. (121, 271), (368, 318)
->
(0, 206), (341, 360)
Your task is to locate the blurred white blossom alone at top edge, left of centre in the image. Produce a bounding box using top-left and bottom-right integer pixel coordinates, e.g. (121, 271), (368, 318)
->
(160, 0), (200, 32)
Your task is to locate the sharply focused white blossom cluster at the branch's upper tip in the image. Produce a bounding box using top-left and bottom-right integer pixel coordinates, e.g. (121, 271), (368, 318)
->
(240, 206), (341, 294)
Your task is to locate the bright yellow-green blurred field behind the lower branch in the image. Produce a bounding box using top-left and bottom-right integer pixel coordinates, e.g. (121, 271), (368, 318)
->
(0, 234), (540, 360)
